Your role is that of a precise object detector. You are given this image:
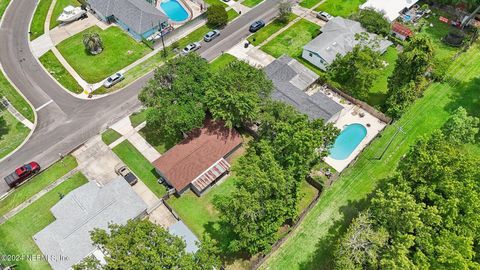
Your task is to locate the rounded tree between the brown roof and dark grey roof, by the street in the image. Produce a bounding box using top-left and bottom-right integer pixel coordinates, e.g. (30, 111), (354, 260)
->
(206, 60), (273, 127)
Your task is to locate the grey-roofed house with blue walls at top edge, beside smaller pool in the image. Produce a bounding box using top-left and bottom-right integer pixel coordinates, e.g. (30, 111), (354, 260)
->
(87, 0), (172, 40)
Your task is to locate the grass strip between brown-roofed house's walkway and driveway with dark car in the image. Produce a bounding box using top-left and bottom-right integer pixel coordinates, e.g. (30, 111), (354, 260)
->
(112, 141), (167, 198)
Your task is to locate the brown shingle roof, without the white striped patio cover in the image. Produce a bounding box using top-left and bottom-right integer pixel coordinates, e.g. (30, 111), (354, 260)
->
(153, 120), (242, 191)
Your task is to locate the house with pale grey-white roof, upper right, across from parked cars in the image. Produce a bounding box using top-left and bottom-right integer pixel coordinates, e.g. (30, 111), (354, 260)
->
(302, 17), (392, 71)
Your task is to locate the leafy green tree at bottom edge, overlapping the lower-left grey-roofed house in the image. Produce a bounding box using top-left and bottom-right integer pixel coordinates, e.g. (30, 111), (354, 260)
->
(74, 220), (220, 270)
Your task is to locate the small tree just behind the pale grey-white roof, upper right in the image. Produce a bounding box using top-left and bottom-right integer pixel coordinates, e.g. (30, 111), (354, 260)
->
(353, 8), (391, 36)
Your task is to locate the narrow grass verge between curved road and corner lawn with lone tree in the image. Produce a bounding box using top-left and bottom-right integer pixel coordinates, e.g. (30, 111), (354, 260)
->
(39, 50), (83, 94)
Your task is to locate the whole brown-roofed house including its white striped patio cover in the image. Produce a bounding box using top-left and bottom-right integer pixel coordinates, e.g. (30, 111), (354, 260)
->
(153, 120), (242, 196)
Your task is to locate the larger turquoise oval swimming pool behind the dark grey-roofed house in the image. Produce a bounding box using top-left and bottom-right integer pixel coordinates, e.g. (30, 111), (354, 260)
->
(330, 124), (367, 160)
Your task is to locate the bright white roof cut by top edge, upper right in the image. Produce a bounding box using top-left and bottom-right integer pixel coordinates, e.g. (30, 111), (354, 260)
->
(360, 0), (418, 22)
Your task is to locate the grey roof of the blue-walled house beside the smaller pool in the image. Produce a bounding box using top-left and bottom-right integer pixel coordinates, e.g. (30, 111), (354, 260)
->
(88, 0), (168, 34)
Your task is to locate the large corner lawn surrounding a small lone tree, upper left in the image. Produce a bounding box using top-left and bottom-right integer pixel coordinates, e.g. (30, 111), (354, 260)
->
(57, 26), (151, 83)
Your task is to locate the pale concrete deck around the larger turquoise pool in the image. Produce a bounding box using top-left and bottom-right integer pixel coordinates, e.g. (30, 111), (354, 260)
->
(313, 87), (387, 172)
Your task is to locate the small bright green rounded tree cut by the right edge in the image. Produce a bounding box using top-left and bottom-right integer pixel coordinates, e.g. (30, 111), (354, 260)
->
(442, 107), (480, 144)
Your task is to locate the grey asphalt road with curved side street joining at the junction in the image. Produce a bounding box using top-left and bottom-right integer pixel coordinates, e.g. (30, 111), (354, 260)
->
(0, 0), (280, 196)
